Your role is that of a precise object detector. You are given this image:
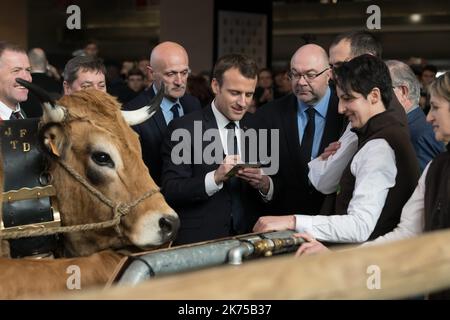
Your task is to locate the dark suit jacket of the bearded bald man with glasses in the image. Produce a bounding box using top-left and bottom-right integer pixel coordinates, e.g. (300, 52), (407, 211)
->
(256, 89), (344, 215)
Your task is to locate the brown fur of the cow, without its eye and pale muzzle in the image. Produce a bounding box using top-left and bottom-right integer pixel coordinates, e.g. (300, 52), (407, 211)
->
(0, 90), (177, 298)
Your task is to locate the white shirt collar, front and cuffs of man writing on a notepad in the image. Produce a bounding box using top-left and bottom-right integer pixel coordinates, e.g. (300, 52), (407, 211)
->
(205, 101), (274, 201)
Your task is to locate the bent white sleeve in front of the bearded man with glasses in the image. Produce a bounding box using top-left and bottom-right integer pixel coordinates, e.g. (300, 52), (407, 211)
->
(308, 123), (358, 194)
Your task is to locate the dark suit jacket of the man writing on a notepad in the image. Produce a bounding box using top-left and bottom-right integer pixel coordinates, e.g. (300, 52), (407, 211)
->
(162, 105), (262, 244)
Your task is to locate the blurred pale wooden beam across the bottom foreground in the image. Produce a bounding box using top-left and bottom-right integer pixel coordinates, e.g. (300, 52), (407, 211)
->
(64, 230), (450, 299)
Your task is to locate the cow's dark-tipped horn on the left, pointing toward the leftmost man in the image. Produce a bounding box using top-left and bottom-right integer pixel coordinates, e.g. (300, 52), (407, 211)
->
(16, 78), (66, 122)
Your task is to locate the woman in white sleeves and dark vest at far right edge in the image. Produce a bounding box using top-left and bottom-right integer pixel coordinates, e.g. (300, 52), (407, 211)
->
(297, 72), (450, 299)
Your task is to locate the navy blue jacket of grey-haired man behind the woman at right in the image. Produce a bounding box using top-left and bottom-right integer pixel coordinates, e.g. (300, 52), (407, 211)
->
(407, 108), (445, 171)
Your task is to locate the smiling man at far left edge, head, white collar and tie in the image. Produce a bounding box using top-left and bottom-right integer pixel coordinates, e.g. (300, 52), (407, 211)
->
(0, 42), (32, 120)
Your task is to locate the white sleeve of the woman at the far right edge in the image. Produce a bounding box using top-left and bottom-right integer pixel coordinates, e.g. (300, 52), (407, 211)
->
(366, 163), (430, 245)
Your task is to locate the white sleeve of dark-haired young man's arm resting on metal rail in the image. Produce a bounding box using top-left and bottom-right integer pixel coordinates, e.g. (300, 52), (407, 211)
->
(295, 139), (397, 243)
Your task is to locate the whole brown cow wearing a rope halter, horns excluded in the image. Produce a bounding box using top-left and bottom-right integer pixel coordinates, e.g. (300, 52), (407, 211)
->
(0, 84), (179, 298)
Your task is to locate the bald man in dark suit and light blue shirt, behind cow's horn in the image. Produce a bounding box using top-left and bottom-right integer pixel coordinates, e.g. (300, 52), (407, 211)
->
(124, 42), (201, 185)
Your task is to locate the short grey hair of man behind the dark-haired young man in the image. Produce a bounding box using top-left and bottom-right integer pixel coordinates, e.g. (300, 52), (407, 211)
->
(386, 60), (420, 105)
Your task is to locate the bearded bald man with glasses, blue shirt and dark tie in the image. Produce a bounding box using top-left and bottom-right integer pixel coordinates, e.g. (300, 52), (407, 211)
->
(253, 44), (343, 220)
